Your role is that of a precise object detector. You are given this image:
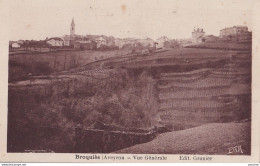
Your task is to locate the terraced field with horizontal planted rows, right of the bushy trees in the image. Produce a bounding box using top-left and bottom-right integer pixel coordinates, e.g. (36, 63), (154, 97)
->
(151, 48), (251, 130)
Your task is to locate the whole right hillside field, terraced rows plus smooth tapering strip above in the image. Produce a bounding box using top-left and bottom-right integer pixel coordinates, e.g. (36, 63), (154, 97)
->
(98, 48), (251, 130)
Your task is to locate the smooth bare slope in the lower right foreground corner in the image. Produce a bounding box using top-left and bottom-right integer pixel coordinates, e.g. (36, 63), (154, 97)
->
(115, 123), (250, 155)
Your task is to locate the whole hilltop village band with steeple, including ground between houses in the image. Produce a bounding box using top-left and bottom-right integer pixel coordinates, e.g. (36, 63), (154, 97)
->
(9, 18), (252, 53)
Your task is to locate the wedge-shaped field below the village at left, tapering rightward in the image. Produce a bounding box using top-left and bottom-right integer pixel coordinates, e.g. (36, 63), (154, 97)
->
(9, 49), (130, 82)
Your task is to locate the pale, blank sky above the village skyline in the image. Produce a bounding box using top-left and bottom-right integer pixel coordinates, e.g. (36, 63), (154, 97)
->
(9, 0), (254, 40)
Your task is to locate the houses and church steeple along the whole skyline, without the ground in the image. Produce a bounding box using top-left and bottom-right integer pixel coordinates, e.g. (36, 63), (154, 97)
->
(9, 19), (252, 50)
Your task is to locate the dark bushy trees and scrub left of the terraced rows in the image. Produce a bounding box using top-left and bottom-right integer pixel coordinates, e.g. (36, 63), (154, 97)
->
(8, 67), (158, 152)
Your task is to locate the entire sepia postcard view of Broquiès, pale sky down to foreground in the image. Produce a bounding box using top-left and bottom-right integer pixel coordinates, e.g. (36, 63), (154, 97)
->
(1, 0), (259, 162)
